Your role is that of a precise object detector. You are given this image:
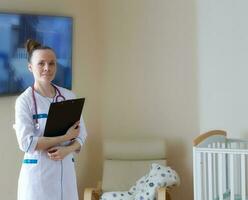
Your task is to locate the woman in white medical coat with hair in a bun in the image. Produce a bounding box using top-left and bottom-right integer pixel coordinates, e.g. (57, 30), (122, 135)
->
(15, 40), (87, 200)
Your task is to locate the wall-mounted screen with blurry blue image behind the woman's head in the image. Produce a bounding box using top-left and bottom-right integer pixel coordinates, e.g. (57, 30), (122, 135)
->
(0, 13), (73, 95)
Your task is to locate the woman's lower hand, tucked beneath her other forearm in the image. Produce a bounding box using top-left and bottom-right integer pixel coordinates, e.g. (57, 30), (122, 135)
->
(47, 146), (70, 160)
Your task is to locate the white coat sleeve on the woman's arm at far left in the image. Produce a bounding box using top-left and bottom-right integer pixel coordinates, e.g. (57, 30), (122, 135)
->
(14, 98), (38, 153)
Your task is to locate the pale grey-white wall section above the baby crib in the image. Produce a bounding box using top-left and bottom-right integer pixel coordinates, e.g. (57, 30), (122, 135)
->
(197, 0), (248, 137)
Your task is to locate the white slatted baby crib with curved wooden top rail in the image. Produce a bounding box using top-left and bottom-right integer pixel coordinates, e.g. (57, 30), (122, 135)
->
(193, 130), (248, 200)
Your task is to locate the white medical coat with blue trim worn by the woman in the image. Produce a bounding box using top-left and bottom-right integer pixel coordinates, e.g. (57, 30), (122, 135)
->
(14, 86), (87, 200)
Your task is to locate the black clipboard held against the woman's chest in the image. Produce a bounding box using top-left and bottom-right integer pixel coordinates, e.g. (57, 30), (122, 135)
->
(44, 98), (85, 137)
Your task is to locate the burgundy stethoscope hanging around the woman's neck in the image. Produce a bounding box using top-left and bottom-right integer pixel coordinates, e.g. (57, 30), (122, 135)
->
(32, 84), (65, 130)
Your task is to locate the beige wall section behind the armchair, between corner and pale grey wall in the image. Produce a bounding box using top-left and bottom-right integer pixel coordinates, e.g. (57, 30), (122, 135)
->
(100, 0), (199, 200)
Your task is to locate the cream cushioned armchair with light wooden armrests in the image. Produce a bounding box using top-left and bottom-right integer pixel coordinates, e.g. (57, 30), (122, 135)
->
(84, 139), (171, 200)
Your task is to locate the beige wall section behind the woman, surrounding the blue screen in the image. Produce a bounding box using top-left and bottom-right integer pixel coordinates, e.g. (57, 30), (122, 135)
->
(0, 0), (102, 200)
